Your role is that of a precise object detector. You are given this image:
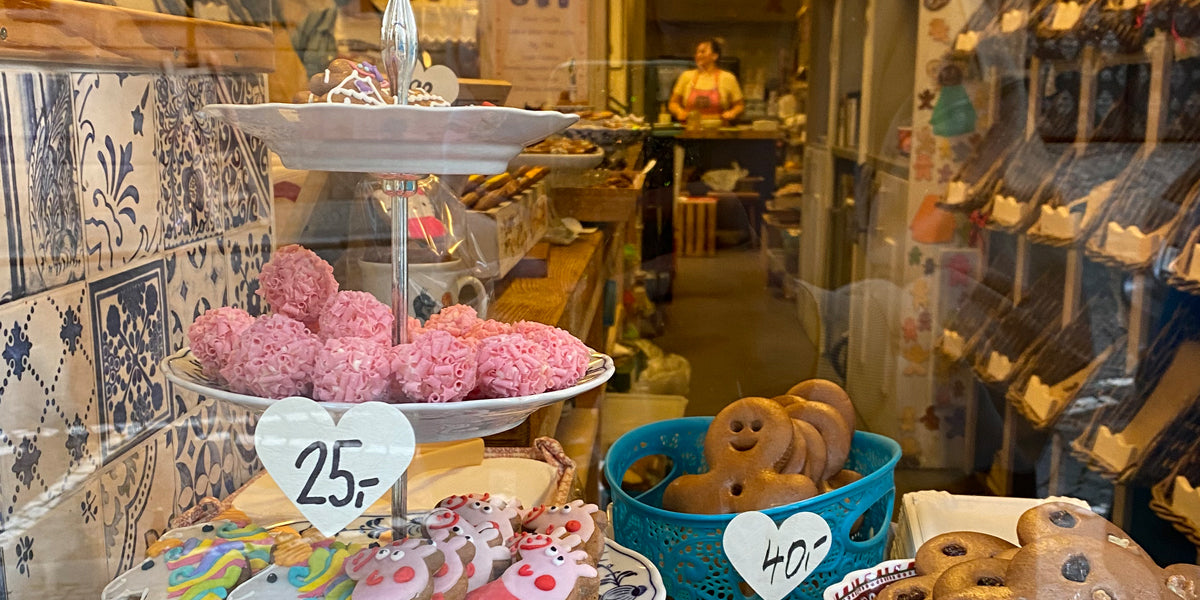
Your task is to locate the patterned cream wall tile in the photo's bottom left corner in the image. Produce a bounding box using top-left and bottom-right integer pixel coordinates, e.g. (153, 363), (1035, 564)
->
(0, 480), (108, 599)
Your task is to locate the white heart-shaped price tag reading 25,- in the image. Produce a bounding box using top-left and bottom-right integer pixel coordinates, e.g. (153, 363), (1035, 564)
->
(254, 397), (416, 535)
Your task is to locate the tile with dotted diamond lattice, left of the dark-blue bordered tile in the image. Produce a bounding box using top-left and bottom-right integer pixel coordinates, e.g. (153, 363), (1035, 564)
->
(0, 283), (100, 523)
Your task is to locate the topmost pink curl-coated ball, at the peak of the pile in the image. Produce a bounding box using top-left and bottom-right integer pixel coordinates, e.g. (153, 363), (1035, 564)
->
(258, 244), (337, 325)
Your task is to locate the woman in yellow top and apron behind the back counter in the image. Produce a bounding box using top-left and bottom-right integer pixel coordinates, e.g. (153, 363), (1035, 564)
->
(667, 40), (745, 122)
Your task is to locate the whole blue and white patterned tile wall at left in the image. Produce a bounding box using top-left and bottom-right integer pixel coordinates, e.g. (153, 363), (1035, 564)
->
(0, 66), (272, 600)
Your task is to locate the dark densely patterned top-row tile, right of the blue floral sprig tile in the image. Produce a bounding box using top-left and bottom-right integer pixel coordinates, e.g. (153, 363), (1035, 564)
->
(154, 74), (228, 248)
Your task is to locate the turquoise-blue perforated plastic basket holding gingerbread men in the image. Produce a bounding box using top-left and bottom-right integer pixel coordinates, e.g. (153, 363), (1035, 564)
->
(605, 416), (900, 600)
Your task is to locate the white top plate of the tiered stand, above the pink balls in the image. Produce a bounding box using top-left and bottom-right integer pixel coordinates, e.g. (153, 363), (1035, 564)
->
(204, 103), (578, 175)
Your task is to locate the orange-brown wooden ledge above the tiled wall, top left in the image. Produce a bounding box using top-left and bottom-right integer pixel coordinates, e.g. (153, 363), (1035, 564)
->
(0, 0), (275, 73)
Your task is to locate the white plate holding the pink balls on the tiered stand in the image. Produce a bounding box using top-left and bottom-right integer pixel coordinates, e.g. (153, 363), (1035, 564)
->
(162, 348), (616, 444)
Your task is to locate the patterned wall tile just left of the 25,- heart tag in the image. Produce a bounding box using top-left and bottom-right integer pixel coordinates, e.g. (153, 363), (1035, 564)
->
(168, 400), (237, 515)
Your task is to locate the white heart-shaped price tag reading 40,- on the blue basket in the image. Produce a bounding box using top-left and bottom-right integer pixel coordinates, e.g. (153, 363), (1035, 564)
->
(721, 512), (833, 600)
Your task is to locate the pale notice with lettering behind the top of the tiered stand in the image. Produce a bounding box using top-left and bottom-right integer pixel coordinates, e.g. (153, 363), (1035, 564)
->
(480, 0), (588, 107)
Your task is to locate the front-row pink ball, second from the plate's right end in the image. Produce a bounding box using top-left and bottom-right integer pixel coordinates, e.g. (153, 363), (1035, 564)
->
(472, 334), (551, 398)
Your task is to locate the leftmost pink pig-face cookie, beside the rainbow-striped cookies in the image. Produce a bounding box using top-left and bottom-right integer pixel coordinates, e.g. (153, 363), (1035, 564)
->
(346, 539), (445, 600)
